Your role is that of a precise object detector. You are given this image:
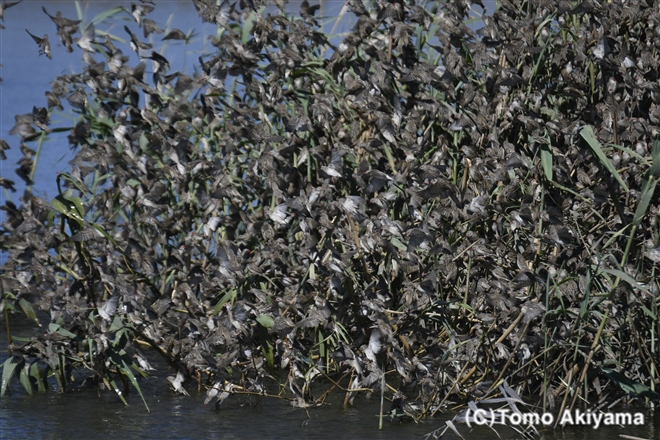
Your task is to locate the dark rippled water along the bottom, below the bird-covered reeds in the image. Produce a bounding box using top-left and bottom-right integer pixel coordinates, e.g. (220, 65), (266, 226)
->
(0, 368), (658, 440)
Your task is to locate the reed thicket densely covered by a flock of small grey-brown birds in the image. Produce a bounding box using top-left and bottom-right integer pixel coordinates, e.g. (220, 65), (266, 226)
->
(0, 0), (660, 426)
